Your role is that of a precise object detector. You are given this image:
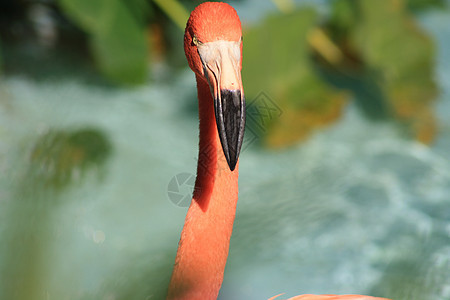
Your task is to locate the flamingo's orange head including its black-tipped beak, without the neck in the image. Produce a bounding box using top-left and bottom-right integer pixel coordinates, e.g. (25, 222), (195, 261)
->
(184, 2), (245, 171)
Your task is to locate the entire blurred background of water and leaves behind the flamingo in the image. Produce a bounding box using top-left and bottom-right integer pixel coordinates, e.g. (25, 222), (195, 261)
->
(0, 0), (450, 300)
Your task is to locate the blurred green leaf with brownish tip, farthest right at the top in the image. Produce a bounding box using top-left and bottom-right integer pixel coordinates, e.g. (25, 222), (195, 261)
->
(354, 0), (437, 142)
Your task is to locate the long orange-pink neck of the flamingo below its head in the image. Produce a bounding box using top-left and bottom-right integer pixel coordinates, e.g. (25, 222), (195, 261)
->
(167, 77), (239, 300)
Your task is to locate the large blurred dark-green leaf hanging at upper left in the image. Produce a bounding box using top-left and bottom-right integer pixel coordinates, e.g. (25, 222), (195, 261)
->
(60, 0), (149, 84)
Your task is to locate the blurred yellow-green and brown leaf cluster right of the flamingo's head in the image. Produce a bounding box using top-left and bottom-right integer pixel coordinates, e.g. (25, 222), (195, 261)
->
(242, 0), (438, 147)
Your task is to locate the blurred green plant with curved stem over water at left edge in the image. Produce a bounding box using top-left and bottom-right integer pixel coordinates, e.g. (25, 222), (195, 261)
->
(0, 128), (111, 299)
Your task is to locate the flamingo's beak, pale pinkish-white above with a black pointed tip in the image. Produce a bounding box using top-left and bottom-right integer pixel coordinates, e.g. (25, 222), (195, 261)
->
(198, 41), (245, 171)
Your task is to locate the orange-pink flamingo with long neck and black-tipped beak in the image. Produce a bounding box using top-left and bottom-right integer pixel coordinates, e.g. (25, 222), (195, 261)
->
(167, 2), (392, 300)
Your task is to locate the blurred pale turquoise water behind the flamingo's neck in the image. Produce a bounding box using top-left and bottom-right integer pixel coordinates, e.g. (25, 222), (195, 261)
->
(0, 5), (450, 300)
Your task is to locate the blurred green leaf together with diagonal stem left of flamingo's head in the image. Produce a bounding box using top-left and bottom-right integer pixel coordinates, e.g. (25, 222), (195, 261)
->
(54, 0), (189, 85)
